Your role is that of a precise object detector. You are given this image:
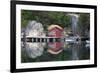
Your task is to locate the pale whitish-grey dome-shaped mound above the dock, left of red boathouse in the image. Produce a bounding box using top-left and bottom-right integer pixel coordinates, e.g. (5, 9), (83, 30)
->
(25, 21), (45, 37)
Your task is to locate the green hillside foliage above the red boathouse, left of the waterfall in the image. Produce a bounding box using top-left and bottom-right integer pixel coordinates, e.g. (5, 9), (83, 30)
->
(21, 10), (71, 28)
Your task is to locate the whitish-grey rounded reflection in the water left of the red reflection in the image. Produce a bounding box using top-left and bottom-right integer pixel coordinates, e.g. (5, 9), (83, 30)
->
(26, 43), (44, 58)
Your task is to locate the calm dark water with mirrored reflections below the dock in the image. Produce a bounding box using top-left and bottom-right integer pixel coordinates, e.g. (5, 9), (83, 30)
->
(21, 42), (90, 63)
